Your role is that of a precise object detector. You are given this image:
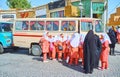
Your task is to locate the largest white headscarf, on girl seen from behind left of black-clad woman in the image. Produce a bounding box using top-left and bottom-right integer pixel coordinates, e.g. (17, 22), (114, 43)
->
(70, 33), (80, 47)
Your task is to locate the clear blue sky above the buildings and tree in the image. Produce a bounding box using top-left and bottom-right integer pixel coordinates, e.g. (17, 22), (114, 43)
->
(0, 0), (120, 17)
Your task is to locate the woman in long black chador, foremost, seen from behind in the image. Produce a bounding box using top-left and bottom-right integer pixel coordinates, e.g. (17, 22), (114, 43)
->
(83, 30), (97, 73)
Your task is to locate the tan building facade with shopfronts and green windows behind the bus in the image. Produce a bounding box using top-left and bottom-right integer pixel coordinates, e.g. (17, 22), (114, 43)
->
(0, 0), (108, 24)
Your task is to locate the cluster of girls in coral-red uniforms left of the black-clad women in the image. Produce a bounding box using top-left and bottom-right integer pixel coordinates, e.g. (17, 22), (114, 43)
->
(40, 32), (85, 65)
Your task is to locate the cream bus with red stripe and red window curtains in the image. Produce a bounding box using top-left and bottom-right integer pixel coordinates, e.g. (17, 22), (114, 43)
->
(13, 18), (105, 55)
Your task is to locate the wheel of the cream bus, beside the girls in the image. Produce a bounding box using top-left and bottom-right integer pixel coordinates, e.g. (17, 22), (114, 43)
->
(31, 45), (42, 56)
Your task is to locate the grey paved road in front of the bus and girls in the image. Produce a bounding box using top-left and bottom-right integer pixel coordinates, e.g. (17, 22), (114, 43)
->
(0, 45), (120, 77)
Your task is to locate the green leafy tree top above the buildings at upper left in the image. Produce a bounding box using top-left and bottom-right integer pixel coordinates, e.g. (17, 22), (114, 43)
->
(6, 0), (31, 9)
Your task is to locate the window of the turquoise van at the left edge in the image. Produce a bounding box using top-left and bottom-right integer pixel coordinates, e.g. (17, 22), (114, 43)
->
(0, 23), (13, 32)
